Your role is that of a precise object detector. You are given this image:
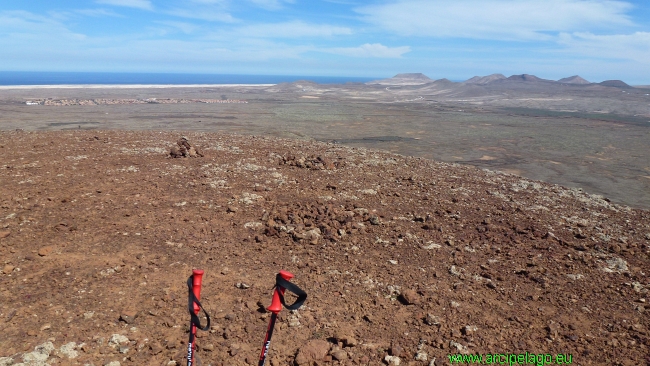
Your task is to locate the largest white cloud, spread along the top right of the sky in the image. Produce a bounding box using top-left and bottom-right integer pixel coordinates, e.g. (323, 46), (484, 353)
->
(356, 0), (634, 40)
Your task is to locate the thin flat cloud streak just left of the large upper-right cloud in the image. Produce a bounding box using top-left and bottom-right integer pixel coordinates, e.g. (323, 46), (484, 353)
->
(236, 21), (352, 38)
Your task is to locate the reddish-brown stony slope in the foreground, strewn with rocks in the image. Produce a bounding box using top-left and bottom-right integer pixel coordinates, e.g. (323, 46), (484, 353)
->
(0, 131), (650, 366)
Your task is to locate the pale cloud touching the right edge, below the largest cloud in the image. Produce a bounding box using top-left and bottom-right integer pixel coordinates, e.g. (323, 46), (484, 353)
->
(559, 32), (650, 65)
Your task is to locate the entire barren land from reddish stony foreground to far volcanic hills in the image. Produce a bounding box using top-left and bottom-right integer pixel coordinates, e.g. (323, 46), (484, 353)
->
(0, 75), (650, 366)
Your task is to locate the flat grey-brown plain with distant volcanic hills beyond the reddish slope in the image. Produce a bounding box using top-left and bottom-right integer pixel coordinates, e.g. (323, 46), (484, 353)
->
(0, 74), (650, 209)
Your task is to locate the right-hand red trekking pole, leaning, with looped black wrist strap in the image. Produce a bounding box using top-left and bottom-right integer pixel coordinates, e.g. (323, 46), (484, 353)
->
(258, 270), (307, 366)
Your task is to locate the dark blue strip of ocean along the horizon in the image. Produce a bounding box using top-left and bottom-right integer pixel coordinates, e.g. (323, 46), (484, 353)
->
(0, 71), (374, 85)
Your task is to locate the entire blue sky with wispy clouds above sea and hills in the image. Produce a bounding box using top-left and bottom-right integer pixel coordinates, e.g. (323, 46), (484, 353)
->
(0, 0), (650, 84)
